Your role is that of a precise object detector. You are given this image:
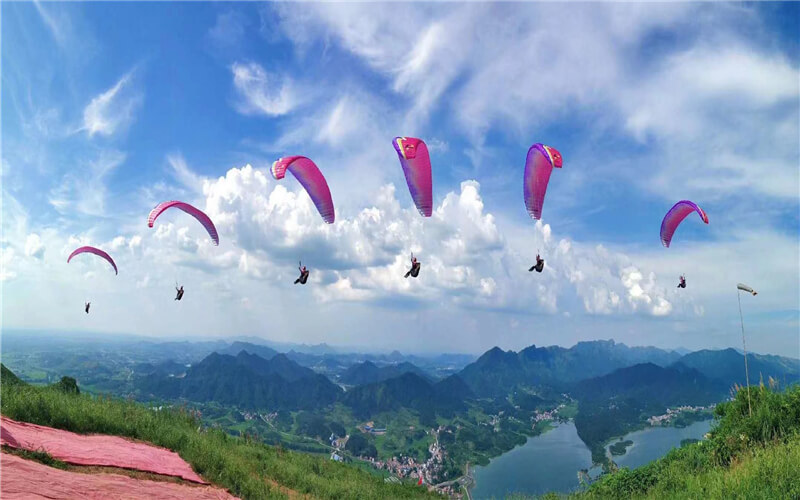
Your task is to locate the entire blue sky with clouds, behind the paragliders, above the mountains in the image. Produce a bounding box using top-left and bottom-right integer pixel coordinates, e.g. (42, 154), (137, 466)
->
(0, 2), (800, 356)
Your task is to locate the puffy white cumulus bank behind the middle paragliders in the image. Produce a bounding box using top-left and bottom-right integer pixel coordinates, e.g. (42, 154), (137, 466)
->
(198, 165), (672, 315)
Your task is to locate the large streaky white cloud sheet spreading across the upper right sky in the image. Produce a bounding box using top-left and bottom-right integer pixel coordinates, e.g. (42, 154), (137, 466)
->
(276, 3), (800, 205)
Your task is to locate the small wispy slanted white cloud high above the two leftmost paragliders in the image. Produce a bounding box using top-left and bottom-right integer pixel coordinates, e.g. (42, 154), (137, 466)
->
(83, 71), (142, 137)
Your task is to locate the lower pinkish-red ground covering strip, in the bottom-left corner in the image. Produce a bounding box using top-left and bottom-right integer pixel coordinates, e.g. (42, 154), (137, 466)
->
(0, 453), (236, 500)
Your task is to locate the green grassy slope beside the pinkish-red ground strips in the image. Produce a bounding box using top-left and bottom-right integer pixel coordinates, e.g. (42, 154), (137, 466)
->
(0, 383), (436, 499)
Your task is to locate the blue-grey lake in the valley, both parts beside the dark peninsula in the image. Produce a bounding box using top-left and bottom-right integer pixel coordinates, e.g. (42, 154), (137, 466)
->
(471, 420), (712, 500)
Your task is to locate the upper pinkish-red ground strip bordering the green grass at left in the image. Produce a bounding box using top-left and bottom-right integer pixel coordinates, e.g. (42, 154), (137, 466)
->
(0, 417), (208, 484)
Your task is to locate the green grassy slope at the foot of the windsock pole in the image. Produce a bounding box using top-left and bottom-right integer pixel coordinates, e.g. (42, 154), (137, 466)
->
(536, 385), (800, 499)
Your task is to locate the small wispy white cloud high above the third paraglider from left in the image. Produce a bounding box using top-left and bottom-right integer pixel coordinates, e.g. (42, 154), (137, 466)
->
(231, 63), (299, 116)
